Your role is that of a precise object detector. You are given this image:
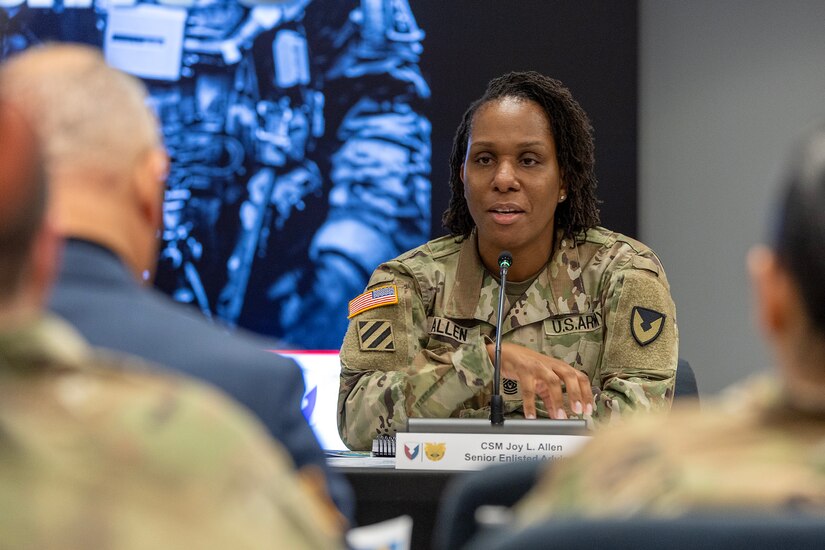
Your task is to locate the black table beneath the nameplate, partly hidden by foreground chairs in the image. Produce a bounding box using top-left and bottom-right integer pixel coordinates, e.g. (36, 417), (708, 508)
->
(327, 453), (458, 550)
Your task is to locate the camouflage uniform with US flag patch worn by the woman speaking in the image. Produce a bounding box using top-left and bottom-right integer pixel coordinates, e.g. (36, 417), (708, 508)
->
(338, 228), (678, 449)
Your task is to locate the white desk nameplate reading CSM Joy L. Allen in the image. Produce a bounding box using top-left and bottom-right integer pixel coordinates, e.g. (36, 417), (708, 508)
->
(395, 432), (590, 470)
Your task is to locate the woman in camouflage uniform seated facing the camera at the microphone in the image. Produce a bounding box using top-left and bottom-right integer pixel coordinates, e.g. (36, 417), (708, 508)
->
(338, 71), (678, 449)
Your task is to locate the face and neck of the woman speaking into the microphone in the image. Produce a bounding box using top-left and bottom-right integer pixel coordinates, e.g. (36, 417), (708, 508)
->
(461, 97), (567, 274)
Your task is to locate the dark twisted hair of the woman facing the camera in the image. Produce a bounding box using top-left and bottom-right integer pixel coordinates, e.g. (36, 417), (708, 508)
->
(441, 71), (599, 237)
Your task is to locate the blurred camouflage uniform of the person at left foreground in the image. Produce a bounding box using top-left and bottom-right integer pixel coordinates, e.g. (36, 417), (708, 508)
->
(0, 319), (340, 550)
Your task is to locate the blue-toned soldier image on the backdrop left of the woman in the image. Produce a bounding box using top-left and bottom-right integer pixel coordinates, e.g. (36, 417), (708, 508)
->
(0, 0), (430, 349)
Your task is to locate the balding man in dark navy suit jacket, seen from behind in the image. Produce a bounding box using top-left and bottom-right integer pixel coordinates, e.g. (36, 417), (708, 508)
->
(0, 44), (354, 519)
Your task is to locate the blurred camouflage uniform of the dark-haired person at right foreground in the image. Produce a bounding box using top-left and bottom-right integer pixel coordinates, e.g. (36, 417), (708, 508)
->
(516, 377), (825, 525)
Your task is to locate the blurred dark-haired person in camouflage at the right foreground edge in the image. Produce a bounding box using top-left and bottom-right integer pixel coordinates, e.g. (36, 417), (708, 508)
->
(517, 124), (825, 525)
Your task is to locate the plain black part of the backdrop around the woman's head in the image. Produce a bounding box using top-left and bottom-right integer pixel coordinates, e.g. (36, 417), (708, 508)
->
(418, 0), (638, 236)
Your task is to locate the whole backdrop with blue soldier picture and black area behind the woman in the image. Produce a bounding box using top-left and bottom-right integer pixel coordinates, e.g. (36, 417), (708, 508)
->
(0, 0), (638, 356)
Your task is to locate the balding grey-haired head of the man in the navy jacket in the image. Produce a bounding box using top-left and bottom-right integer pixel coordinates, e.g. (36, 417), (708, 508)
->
(0, 44), (168, 280)
